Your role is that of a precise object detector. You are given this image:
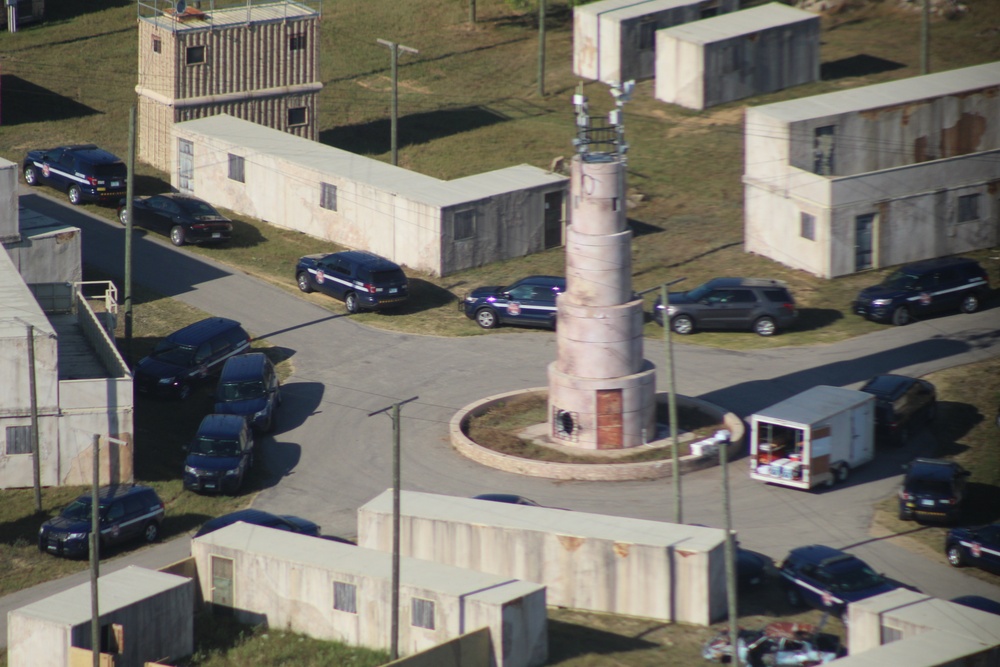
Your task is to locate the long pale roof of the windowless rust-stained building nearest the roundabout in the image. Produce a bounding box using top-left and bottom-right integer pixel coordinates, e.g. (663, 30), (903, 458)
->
(359, 490), (726, 553)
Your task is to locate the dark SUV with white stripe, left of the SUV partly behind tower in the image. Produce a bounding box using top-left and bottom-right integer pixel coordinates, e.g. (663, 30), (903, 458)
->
(295, 250), (408, 313)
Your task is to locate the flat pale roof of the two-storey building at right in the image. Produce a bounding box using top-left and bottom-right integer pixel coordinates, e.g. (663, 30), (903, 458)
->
(752, 60), (1000, 123)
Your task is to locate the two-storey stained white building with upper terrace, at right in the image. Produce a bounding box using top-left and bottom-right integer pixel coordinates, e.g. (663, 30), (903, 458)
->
(743, 62), (1000, 278)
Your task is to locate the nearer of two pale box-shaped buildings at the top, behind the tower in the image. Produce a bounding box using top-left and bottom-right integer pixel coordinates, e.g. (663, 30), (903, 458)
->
(655, 2), (820, 109)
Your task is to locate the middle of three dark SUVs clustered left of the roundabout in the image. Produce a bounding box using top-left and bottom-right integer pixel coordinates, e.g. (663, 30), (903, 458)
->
(215, 352), (281, 431)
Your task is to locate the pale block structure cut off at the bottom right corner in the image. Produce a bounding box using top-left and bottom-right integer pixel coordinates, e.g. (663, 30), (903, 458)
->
(837, 588), (1000, 667)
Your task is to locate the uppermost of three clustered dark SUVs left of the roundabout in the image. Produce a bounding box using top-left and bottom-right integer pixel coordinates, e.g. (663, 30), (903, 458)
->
(135, 317), (250, 399)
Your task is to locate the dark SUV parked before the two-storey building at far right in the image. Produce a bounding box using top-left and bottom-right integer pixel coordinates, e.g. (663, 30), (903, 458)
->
(854, 257), (989, 326)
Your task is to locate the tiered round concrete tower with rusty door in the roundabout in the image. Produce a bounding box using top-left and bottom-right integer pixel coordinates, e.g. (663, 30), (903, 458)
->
(549, 82), (656, 449)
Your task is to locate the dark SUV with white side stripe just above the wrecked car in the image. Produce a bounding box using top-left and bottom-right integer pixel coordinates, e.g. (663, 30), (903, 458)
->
(778, 544), (900, 616)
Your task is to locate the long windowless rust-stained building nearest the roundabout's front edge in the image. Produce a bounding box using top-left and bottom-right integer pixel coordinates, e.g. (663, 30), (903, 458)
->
(358, 490), (726, 625)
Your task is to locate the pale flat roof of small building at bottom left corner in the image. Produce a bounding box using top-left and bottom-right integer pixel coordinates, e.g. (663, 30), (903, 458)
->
(10, 565), (194, 626)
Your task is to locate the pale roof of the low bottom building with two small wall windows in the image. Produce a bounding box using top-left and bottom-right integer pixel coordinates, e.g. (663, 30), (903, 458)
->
(192, 521), (544, 600)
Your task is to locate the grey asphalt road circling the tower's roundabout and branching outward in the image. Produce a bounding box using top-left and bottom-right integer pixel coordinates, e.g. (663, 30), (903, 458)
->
(7, 190), (1000, 640)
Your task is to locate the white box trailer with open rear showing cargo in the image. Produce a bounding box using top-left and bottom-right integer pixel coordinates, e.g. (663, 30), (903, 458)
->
(750, 385), (875, 489)
